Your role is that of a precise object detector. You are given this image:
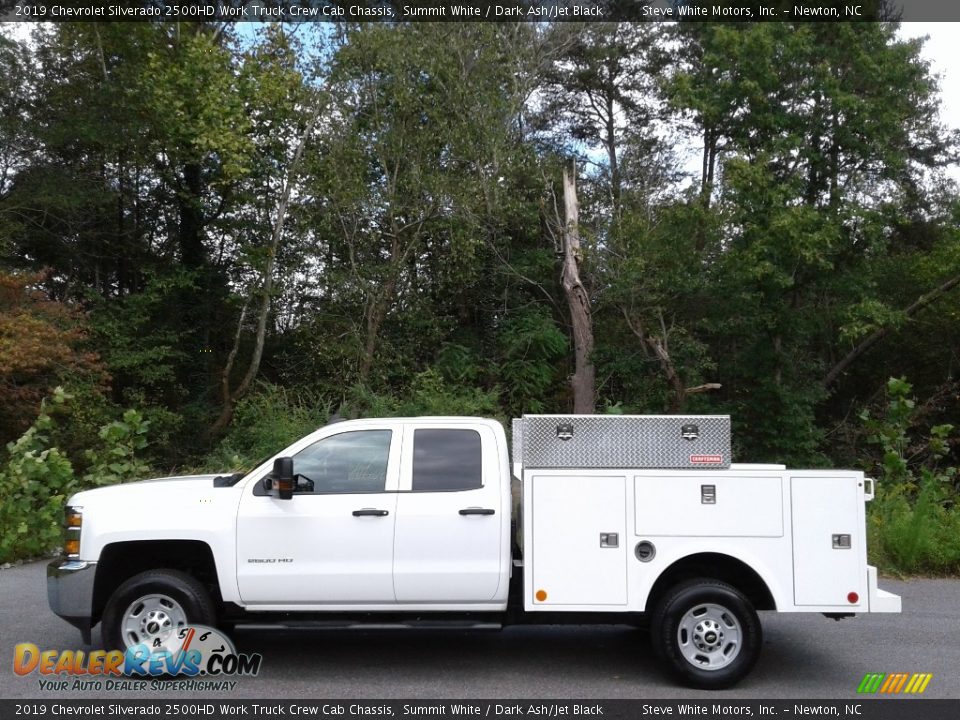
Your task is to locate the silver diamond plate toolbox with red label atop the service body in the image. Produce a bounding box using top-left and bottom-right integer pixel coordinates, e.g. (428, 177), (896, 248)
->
(512, 415), (730, 469)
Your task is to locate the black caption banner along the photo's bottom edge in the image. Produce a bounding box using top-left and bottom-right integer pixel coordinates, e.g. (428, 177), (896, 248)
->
(0, 698), (960, 720)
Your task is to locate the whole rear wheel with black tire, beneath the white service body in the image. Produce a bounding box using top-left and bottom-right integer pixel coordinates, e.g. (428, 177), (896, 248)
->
(650, 580), (763, 690)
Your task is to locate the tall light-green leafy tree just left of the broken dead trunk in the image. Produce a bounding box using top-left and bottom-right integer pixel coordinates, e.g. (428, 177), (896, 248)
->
(311, 25), (537, 382)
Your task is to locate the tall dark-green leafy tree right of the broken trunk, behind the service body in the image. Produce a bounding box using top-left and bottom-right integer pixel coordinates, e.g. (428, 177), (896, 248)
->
(673, 23), (949, 460)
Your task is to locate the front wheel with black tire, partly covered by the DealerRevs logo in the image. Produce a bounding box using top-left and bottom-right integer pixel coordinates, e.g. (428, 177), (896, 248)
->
(101, 570), (217, 651)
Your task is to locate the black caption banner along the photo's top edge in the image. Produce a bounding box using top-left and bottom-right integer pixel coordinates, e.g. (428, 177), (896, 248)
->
(0, 0), (944, 23)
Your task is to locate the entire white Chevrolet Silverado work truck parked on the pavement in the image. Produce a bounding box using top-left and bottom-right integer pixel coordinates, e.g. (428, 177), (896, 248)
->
(47, 415), (900, 688)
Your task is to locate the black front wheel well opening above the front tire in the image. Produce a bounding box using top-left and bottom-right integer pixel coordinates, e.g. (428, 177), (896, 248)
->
(93, 540), (222, 624)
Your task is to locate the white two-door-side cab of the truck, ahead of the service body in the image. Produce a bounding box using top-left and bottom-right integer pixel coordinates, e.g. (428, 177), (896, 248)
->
(235, 418), (510, 611)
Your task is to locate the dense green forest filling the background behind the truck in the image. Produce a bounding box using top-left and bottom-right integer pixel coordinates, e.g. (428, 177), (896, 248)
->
(0, 23), (960, 571)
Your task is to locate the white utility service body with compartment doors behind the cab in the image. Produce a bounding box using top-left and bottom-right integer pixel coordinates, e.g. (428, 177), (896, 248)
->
(524, 465), (900, 613)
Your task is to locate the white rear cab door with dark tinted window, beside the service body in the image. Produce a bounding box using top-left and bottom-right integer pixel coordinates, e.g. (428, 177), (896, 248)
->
(394, 425), (510, 603)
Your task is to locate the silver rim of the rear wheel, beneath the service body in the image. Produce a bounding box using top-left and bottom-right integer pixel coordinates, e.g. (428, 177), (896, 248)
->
(677, 603), (743, 670)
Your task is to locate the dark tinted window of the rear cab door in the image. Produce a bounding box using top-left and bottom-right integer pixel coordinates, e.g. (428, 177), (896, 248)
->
(413, 429), (483, 492)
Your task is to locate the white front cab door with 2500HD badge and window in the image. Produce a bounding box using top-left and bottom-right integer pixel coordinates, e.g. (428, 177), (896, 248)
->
(237, 426), (402, 605)
